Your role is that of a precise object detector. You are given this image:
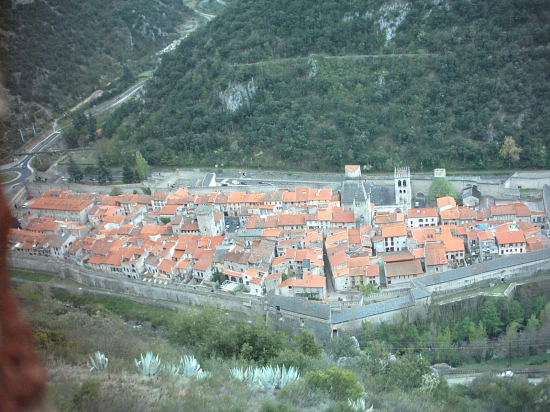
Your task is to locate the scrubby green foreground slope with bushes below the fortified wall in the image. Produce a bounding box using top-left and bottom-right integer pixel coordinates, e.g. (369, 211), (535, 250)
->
(16, 283), (550, 412)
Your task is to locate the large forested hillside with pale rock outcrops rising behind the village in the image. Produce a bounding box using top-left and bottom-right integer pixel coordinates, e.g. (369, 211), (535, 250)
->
(97, 0), (550, 171)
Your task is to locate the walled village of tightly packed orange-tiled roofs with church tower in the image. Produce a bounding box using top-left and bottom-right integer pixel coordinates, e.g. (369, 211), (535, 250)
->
(9, 165), (550, 301)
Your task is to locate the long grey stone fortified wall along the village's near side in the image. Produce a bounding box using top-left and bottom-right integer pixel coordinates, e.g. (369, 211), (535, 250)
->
(9, 243), (550, 342)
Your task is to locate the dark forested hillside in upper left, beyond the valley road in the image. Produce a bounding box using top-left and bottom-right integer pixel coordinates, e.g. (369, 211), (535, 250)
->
(0, 0), (194, 151)
